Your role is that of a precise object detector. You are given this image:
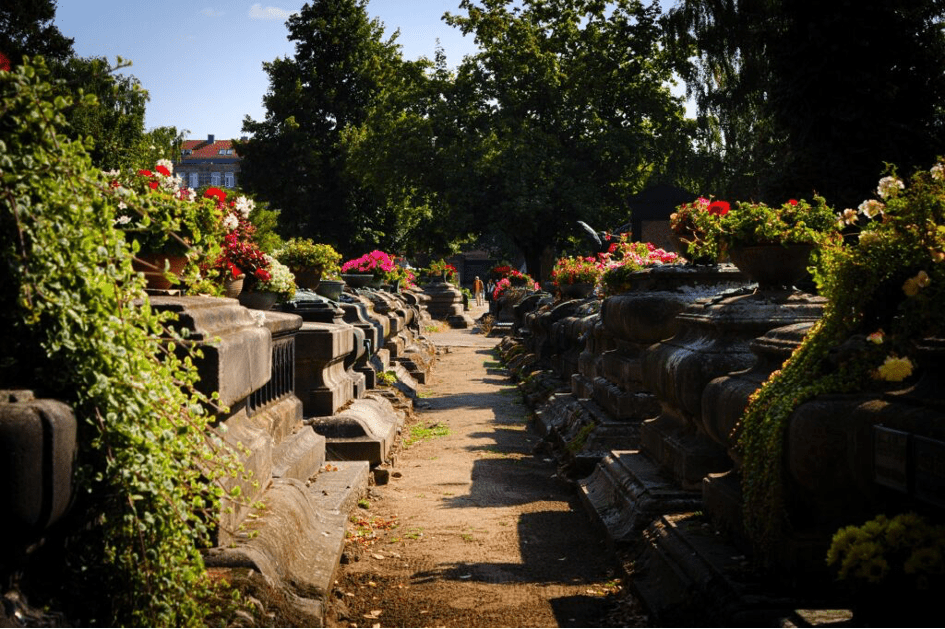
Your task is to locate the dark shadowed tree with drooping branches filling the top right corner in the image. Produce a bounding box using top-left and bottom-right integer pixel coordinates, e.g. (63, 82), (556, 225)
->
(667, 0), (945, 206)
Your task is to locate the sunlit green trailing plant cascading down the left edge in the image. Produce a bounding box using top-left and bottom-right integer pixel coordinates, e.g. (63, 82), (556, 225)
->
(0, 58), (239, 626)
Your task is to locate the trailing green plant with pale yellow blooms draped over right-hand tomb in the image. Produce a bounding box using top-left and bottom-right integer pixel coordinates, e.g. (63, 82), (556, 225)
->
(736, 163), (945, 562)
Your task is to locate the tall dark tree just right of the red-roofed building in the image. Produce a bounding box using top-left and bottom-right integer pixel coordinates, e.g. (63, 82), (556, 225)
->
(237, 0), (410, 254)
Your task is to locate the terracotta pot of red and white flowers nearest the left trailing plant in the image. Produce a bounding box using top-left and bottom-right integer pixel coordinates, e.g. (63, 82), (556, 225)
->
(108, 160), (223, 289)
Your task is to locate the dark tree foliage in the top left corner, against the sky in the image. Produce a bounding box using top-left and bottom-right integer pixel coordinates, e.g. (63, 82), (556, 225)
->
(0, 0), (74, 65)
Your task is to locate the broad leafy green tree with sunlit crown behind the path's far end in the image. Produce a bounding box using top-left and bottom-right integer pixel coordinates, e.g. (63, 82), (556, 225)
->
(438, 0), (689, 275)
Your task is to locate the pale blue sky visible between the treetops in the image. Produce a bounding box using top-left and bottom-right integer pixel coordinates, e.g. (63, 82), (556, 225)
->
(56, 0), (684, 139)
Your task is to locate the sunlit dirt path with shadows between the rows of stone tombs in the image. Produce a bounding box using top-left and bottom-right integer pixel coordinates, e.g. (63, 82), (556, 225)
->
(329, 311), (640, 627)
